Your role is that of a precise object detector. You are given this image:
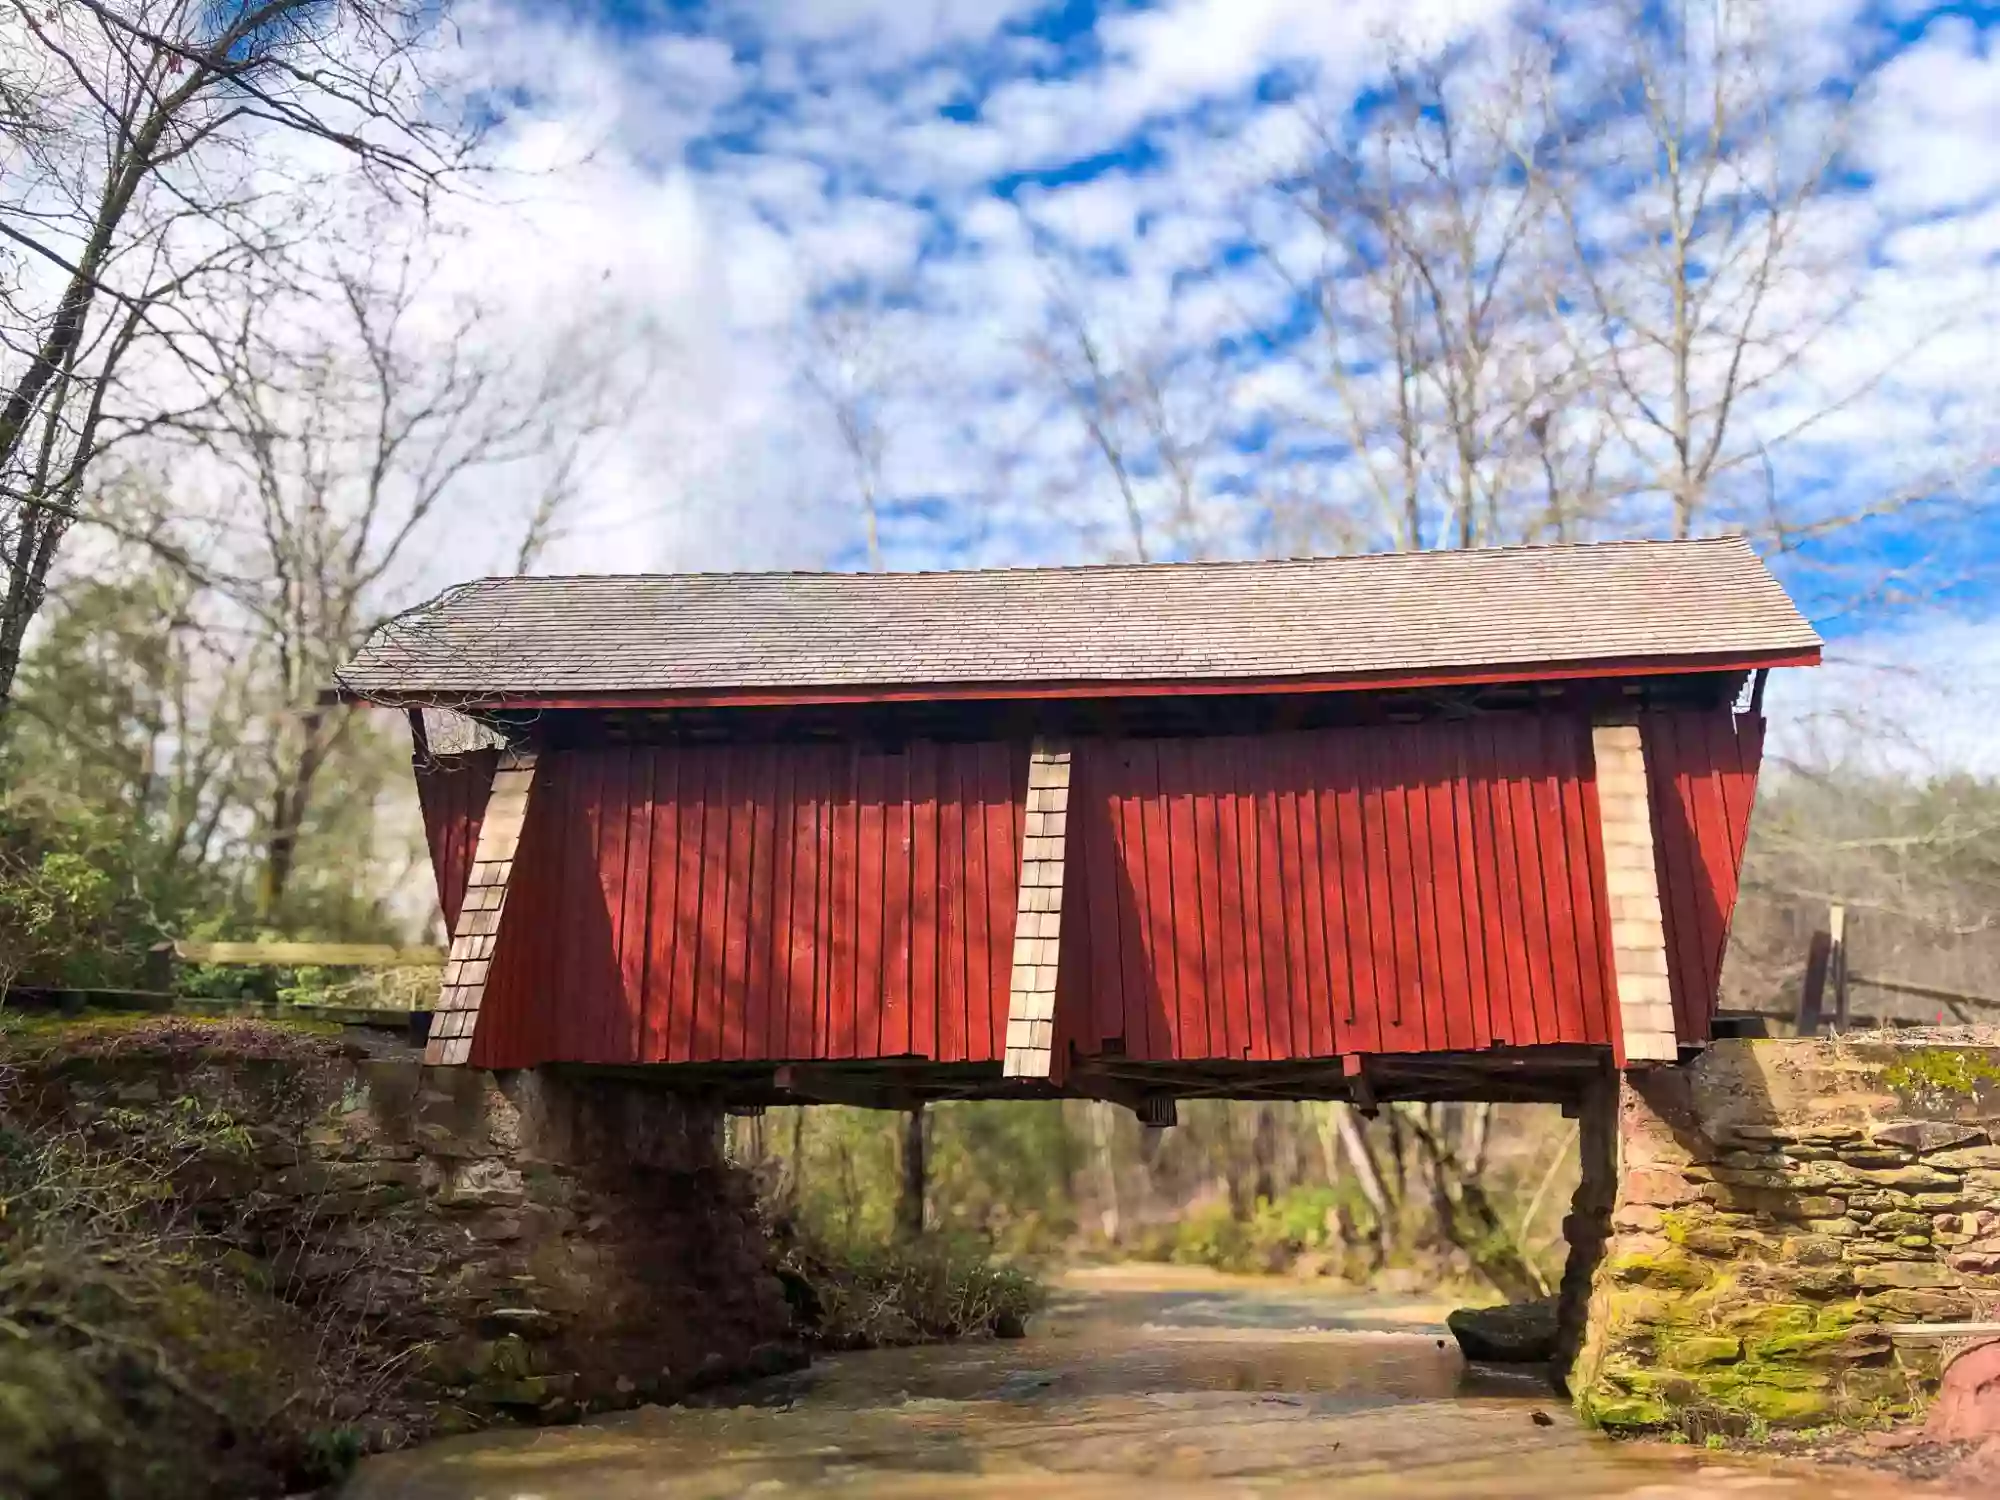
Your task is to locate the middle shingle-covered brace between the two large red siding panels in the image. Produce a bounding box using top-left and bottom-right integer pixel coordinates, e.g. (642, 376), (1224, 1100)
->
(1000, 740), (1070, 1078)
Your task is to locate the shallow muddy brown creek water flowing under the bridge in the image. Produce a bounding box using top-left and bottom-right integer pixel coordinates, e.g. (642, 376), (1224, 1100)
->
(346, 1268), (1948, 1500)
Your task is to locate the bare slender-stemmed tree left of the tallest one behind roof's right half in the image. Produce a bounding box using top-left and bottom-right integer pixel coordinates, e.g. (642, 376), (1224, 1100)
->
(1252, 48), (1590, 550)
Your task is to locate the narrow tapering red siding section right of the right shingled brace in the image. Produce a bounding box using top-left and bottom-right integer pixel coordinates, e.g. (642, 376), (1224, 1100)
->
(1640, 712), (1764, 1042)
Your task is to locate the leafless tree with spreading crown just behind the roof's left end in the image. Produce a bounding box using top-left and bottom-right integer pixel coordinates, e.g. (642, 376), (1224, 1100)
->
(184, 244), (620, 920)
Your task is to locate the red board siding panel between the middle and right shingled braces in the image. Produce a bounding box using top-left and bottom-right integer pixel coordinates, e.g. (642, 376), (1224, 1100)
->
(1058, 718), (1610, 1060)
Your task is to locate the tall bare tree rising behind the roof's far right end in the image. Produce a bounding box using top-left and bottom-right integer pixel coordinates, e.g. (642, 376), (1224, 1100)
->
(1522, 0), (1864, 536)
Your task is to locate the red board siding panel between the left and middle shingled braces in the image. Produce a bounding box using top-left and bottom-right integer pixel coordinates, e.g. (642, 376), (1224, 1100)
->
(472, 742), (1026, 1068)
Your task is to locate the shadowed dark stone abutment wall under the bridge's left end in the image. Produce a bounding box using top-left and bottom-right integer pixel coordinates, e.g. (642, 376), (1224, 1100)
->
(0, 1022), (802, 1446)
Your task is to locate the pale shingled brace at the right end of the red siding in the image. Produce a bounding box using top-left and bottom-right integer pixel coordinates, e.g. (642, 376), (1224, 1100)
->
(1590, 724), (1680, 1062)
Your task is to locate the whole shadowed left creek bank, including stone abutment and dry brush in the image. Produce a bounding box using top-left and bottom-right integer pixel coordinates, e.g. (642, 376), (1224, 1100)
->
(0, 1018), (806, 1500)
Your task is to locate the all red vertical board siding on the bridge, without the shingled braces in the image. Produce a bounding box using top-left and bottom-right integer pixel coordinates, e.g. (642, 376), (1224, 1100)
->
(418, 712), (1764, 1068)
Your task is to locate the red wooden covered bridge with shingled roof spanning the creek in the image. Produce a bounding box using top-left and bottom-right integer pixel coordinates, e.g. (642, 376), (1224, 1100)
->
(340, 540), (1818, 1108)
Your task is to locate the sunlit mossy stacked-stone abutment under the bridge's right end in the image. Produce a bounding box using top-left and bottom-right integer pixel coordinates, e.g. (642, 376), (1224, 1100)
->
(1570, 1036), (2000, 1436)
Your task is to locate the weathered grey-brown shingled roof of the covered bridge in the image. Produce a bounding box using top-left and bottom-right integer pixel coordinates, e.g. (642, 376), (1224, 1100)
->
(340, 538), (1820, 700)
